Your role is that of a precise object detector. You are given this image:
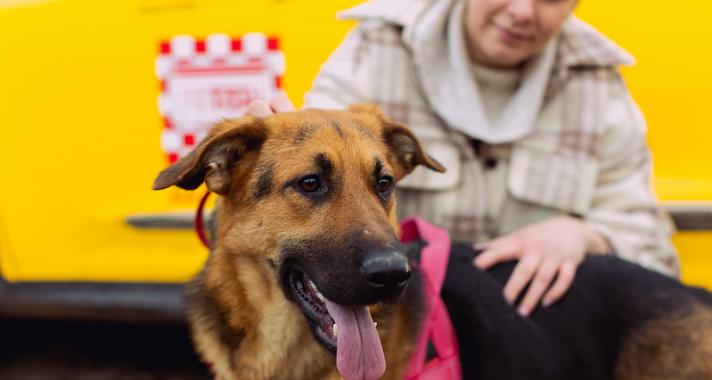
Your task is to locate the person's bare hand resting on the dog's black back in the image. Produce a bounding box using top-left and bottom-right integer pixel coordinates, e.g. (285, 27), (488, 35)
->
(474, 216), (611, 316)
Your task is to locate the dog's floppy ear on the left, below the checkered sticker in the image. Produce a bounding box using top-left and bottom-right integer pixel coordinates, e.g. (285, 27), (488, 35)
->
(153, 116), (267, 195)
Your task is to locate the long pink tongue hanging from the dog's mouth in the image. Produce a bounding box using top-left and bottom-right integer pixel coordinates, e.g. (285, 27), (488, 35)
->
(326, 300), (386, 380)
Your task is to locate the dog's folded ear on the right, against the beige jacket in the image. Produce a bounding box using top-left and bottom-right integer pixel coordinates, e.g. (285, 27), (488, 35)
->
(382, 121), (445, 177)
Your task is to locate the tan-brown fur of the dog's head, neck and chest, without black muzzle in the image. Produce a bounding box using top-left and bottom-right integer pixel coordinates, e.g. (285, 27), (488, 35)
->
(154, 106), (444, 380)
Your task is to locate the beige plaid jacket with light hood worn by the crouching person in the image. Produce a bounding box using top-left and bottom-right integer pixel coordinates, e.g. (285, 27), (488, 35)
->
(305, 0), (679, 275)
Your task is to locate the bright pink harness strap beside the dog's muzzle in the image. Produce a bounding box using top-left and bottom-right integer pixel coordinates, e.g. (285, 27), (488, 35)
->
(401, 218), (462, 380)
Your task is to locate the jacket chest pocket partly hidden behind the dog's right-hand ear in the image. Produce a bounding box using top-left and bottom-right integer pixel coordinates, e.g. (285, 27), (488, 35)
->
(398, 139), (461, 191)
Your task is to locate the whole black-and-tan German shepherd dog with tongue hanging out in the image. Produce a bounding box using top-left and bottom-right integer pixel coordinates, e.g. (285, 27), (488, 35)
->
(154, 106), (712, 380)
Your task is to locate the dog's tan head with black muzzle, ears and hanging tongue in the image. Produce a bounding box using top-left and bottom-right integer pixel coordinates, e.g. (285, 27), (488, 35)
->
(154, 106), (445, 378)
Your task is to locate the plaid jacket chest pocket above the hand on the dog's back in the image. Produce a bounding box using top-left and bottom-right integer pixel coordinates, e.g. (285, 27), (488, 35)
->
(507, 145), (598, 215)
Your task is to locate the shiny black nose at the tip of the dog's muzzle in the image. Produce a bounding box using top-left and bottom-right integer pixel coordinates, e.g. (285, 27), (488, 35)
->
(361, 250), (410, 287)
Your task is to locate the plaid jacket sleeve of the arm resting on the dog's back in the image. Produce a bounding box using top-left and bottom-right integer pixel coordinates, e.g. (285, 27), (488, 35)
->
(585, 76), (679, 276)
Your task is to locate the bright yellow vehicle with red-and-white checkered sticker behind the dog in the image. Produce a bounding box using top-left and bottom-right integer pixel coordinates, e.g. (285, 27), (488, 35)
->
(0, 0), (712, 317)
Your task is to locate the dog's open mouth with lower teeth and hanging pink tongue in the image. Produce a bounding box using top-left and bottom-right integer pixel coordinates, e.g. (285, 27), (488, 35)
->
(289, 270), (386, 380)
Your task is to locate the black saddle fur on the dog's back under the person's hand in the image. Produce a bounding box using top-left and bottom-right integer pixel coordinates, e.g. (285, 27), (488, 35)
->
(407, 242), (712, 380)
